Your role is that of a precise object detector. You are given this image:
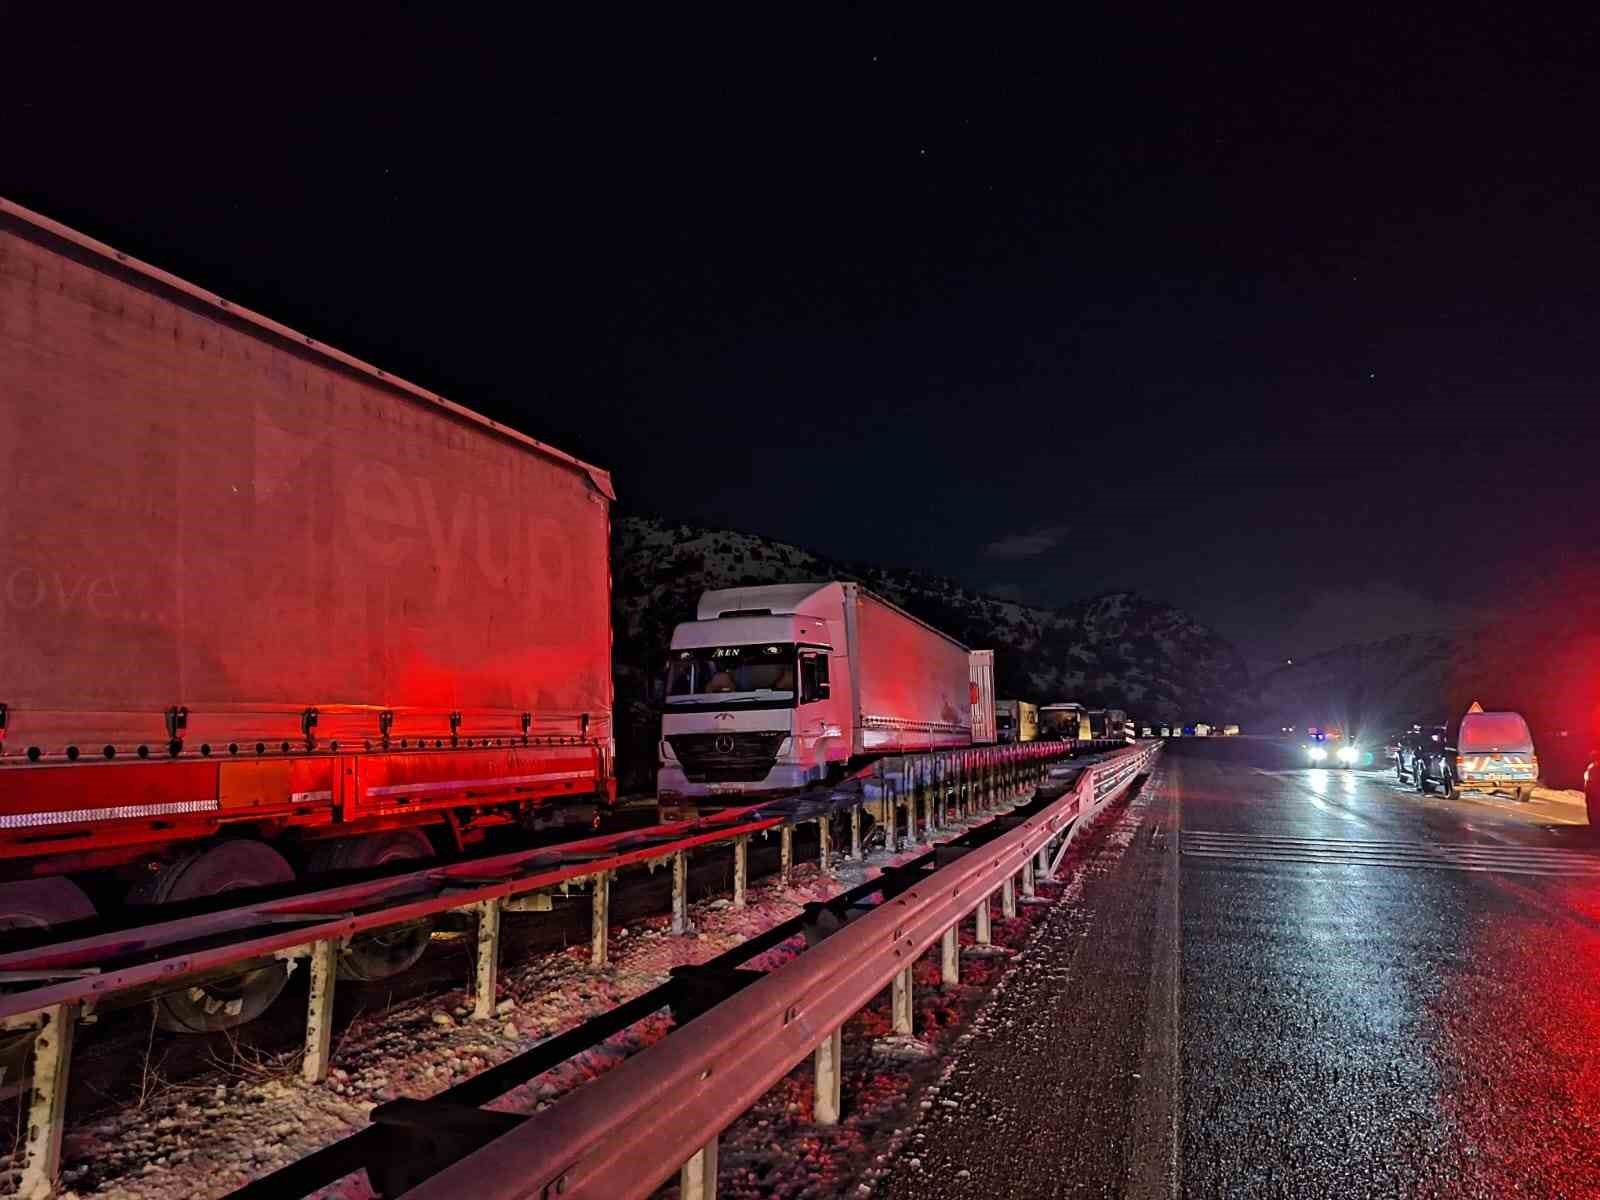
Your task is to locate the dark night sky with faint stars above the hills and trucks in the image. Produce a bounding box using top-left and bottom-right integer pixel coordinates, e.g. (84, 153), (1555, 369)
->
(9, 5), (1600, 672)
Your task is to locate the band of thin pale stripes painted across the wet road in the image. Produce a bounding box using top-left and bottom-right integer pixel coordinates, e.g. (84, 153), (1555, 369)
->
(1182, 829), (1600, 878)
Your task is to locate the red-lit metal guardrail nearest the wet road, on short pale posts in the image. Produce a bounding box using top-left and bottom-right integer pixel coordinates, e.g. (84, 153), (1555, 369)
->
(406, 744), (1160, 1200)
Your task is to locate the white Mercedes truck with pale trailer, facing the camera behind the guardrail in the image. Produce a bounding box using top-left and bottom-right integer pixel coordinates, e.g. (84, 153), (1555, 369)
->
(656, 581), (972, 818)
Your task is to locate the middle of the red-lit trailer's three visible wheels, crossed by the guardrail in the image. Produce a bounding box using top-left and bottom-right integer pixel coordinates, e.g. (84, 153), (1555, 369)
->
(128, 842), (294, 1034)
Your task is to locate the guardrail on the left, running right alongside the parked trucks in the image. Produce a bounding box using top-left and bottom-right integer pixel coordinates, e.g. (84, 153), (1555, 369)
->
(0, 742), (1090, 1200)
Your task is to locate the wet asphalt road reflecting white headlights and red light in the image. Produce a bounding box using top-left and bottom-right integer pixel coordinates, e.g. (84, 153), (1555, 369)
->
(885, 739), (1600, 1200)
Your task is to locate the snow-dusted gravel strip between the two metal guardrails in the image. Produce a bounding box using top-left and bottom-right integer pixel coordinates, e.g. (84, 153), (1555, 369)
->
(0, 848), (925, 1200)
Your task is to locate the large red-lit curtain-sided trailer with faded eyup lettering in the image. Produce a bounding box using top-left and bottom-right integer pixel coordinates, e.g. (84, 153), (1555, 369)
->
(0, 200), (616, 1029)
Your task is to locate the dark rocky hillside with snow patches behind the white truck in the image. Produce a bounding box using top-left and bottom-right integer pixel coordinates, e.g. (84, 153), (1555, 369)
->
(611, 517), (1248, 782)
